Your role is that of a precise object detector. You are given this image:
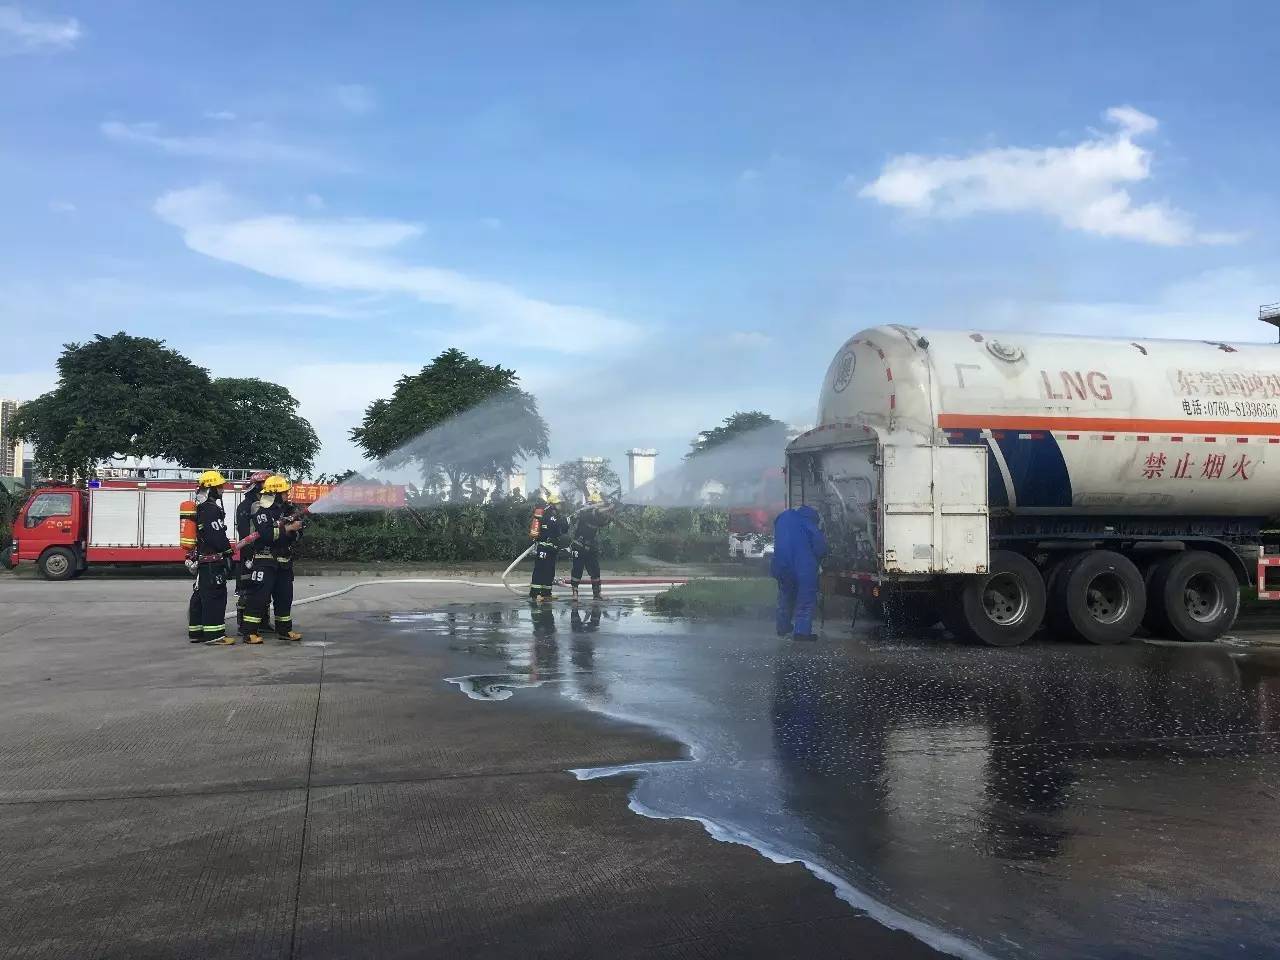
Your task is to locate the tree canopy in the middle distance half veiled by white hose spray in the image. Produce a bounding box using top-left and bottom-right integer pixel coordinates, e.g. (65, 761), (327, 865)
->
(351, 348), (548, 500)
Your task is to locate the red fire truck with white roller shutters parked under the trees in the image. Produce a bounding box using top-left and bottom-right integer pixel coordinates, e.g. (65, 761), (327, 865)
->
(9, 468), (264, 580)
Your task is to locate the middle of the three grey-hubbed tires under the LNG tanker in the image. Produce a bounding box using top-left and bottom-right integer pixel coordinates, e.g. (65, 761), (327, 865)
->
(1050, 550), (1147, 644)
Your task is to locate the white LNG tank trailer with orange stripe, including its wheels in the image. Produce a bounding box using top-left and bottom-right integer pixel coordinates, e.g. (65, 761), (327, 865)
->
(787, 325), (1280, 646)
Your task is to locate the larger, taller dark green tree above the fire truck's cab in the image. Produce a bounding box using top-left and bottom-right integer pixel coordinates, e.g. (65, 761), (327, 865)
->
(13, 333), (218, 480)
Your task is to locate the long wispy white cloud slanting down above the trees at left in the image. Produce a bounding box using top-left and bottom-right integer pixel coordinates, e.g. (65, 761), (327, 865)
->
(155, 184), (641, 353)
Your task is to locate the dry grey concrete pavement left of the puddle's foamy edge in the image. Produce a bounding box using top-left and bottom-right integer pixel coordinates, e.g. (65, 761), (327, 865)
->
(0, 579), (934, 960)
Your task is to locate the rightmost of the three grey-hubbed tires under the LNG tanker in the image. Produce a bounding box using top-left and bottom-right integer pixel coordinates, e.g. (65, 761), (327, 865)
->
(1149, 550), (1240, 643)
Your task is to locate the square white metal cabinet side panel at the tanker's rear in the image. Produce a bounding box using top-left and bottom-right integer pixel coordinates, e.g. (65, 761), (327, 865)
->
(881, 444), (989, 573)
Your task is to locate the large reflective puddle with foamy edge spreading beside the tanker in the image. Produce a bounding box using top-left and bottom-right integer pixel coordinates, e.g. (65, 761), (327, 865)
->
(387, 604), (1280, 957)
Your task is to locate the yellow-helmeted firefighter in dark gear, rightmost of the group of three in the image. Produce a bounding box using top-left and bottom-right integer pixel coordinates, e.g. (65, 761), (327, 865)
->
(244, 476), (302, 644)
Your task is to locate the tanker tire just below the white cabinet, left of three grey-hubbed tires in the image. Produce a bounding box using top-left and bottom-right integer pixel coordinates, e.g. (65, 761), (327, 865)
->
(947, 550), (1044, 646)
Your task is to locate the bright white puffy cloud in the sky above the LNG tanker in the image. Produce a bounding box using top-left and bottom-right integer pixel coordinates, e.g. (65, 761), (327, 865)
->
(858, 106), (1240, 246)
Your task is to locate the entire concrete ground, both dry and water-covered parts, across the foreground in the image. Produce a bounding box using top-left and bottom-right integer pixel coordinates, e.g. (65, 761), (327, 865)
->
(0, 581), (1280, 957)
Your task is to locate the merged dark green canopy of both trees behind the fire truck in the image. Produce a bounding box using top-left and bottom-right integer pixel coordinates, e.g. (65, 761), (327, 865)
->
(14, 333), (320, 480)
